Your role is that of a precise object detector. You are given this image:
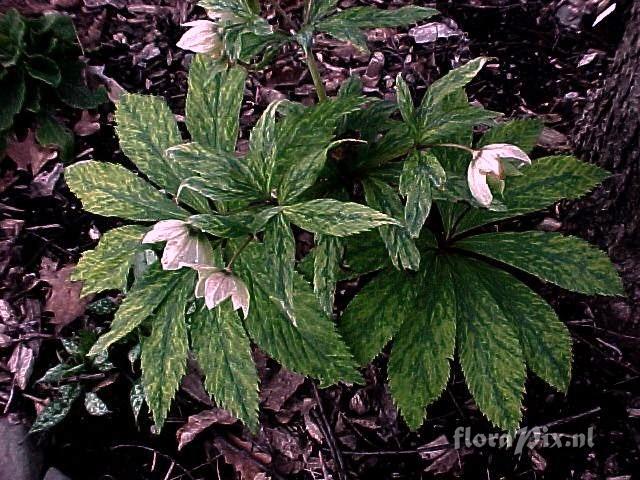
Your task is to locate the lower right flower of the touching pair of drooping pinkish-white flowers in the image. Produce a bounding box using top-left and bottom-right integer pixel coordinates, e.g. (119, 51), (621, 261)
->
(194, 265), (249, 318)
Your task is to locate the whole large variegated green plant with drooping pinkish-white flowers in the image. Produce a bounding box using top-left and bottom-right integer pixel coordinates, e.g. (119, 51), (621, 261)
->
(66, 0), (621, 436)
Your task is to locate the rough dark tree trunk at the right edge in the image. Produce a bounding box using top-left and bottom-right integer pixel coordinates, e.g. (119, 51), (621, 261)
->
(574, 1), (640, 249)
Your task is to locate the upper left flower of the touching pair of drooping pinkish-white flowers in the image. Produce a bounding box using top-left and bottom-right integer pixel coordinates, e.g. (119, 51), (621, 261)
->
(142, 220), (213, 270)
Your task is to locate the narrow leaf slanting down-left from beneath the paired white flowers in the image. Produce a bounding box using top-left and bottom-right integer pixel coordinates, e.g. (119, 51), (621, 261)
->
(89, 263), (193, 356)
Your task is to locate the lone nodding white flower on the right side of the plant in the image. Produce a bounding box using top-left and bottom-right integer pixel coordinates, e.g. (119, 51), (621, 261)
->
(467, 143), (531, 207)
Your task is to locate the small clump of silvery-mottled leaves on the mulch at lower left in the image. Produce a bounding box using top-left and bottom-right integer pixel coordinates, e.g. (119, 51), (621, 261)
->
(29, 330), (115, 433)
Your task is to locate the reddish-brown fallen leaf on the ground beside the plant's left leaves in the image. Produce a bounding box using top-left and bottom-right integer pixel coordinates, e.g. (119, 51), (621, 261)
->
(40, 257), (92, 332)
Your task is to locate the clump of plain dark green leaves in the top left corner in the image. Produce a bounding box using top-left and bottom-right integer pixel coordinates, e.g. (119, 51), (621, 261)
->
(0, 8), (107, 160)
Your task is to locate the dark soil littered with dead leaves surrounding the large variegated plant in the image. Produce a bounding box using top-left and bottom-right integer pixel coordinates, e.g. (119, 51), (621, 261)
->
(0, 0), (640, 480)
